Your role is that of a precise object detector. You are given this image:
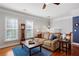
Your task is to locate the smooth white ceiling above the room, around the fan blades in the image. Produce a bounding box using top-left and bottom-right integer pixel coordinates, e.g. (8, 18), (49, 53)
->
(0, 3), (79, 17)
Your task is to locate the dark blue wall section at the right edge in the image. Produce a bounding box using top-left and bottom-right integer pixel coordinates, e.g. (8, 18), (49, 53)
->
(73, 16), (79, 43)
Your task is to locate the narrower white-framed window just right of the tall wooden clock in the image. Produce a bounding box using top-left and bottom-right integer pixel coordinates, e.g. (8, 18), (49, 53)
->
(26, 21), (33, 38)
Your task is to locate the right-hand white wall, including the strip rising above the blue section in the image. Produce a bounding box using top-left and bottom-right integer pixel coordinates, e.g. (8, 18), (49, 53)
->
(50, 9), (79, 33)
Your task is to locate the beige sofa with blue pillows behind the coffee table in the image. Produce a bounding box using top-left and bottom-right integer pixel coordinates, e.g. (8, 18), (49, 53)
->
(34, 32), (61, 51)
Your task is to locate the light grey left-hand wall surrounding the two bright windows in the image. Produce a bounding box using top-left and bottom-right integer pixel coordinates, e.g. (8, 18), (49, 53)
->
(0, 8), (48, 48)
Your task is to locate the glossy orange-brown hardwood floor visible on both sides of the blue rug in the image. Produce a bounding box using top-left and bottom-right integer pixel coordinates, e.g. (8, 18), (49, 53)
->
(0, 45), (79, 56)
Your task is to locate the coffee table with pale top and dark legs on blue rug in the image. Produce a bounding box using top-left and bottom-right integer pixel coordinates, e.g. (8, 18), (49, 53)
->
(21, 39), (42, 56)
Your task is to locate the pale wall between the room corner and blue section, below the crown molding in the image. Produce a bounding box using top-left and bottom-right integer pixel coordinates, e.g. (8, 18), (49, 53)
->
(51, 16), (72, 33)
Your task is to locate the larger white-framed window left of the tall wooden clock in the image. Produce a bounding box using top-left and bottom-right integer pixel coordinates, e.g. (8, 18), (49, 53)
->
(5, 17), (18, 41)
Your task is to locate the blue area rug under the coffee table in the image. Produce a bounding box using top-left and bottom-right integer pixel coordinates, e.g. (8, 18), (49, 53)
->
(12, 47), (52, 56)
